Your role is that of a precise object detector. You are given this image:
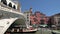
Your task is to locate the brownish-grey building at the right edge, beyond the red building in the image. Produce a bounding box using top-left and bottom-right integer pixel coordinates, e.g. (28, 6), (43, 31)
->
(50, 13), (60, 29)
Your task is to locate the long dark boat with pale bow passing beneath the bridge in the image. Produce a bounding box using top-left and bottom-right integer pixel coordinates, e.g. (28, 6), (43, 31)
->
(6, 26), (37, 34)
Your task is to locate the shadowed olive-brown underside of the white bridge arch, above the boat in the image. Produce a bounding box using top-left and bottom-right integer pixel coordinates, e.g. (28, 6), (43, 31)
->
(5, 17), (26, 33)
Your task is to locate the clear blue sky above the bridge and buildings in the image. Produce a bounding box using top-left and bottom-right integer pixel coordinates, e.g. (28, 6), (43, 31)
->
(19, 0), (60, 16)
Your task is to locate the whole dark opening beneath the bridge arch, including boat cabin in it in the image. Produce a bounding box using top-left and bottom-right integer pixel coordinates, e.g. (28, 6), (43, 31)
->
(5, 19), (26, 34)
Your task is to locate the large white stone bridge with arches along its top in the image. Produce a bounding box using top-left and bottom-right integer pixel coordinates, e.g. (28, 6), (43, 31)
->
(0, 0), (26, 34)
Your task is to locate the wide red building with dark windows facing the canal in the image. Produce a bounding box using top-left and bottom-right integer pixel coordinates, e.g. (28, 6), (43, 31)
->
(30, 11), (48, 24)
